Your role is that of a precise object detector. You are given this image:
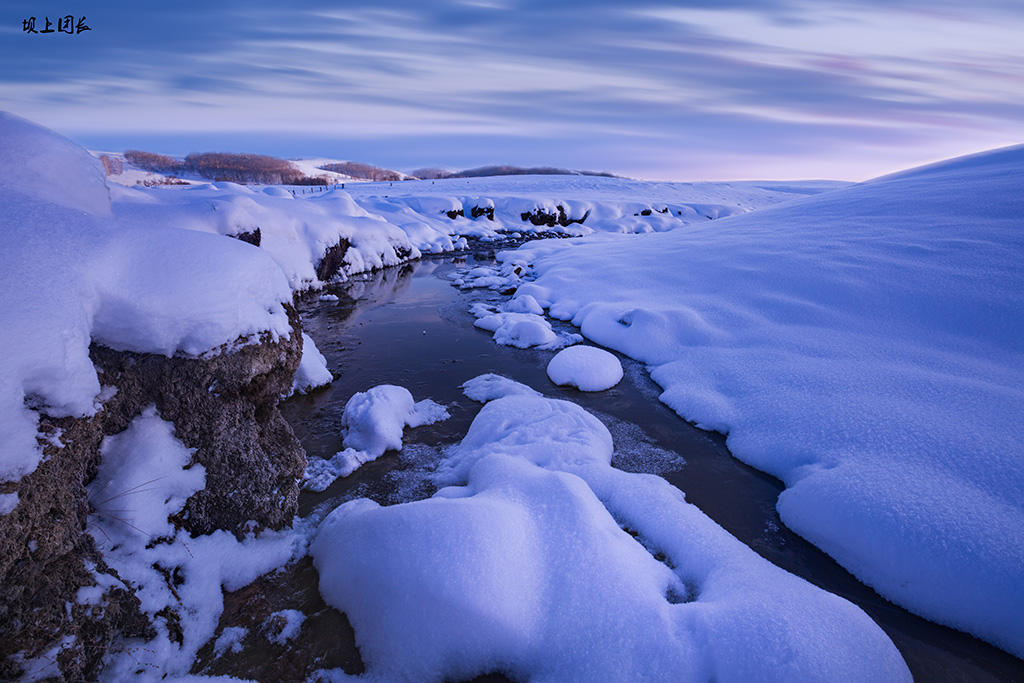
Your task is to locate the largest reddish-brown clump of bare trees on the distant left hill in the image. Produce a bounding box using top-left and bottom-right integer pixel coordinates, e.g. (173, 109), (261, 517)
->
(125, 150), (329, 185)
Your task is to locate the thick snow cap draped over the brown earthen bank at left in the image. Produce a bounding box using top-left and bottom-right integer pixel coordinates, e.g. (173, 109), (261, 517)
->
(0, 114), (291, 482)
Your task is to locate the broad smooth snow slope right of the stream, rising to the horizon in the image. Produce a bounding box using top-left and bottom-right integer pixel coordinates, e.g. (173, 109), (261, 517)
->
(516, 147), (1024, 656)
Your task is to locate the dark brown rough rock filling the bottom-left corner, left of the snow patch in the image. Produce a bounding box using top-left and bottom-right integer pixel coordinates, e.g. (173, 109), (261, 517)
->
(0, 415), (155, 681)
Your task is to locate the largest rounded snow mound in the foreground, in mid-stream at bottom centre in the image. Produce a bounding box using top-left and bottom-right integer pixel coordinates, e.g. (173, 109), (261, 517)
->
(310, 380), (910, 682)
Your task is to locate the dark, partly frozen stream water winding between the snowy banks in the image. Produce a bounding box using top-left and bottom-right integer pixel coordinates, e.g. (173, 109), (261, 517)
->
(218, 256), (1024, 681)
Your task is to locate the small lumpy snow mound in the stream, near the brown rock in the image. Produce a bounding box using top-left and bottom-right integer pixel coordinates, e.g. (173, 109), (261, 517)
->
(302, 384), (449, 490)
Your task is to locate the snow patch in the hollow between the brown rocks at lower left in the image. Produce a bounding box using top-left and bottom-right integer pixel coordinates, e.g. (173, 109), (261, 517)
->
(88, 409), (309, 683)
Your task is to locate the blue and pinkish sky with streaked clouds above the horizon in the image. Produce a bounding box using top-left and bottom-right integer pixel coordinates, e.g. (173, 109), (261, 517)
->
(0, 0), (1024, 181)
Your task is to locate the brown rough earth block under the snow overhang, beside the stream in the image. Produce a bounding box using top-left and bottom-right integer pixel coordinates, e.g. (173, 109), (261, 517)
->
(89, 307), (305, 537)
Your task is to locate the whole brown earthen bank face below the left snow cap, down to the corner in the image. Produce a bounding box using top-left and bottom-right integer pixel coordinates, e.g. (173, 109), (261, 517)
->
(0, 308), (305, 681)
